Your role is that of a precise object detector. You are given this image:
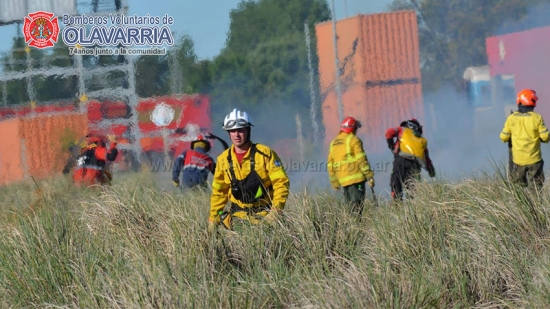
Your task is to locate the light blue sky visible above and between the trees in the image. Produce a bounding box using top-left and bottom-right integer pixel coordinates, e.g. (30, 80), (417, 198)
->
(0, 0), (392, 59)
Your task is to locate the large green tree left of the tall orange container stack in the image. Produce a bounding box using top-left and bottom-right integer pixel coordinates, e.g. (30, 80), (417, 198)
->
(210, 0), (330, 137)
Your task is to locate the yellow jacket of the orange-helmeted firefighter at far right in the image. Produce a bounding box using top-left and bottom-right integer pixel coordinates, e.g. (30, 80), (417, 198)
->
(500, 112), (550, 165)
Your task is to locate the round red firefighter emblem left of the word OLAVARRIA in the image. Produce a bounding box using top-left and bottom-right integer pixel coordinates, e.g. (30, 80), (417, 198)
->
(23, 12), (59, 48)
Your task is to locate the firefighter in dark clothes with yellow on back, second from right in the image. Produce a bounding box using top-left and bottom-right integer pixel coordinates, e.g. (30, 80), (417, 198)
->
(385, 118), (435, 200)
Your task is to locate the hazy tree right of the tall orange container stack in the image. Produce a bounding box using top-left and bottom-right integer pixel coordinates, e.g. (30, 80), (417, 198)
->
(390, 0), (548, 92)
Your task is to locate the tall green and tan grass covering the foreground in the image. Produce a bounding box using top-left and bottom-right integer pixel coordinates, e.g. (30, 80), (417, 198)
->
(0, 172), (550, 308)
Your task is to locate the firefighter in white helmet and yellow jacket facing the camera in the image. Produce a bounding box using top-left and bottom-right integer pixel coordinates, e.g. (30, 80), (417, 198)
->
(208, 109), (290, 231)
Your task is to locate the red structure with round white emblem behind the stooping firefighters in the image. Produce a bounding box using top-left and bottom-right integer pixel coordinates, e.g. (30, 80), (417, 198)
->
(88, 95), (211, 169)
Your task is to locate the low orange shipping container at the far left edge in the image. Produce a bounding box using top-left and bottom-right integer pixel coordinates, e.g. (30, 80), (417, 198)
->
(0, 113), (88, 185)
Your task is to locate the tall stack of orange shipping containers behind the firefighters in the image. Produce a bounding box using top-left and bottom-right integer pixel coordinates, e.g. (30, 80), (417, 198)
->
(315, 11), (424, 153)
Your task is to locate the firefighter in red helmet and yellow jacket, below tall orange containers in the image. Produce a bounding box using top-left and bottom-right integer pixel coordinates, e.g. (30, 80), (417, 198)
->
(327, 117), (374, 215)
